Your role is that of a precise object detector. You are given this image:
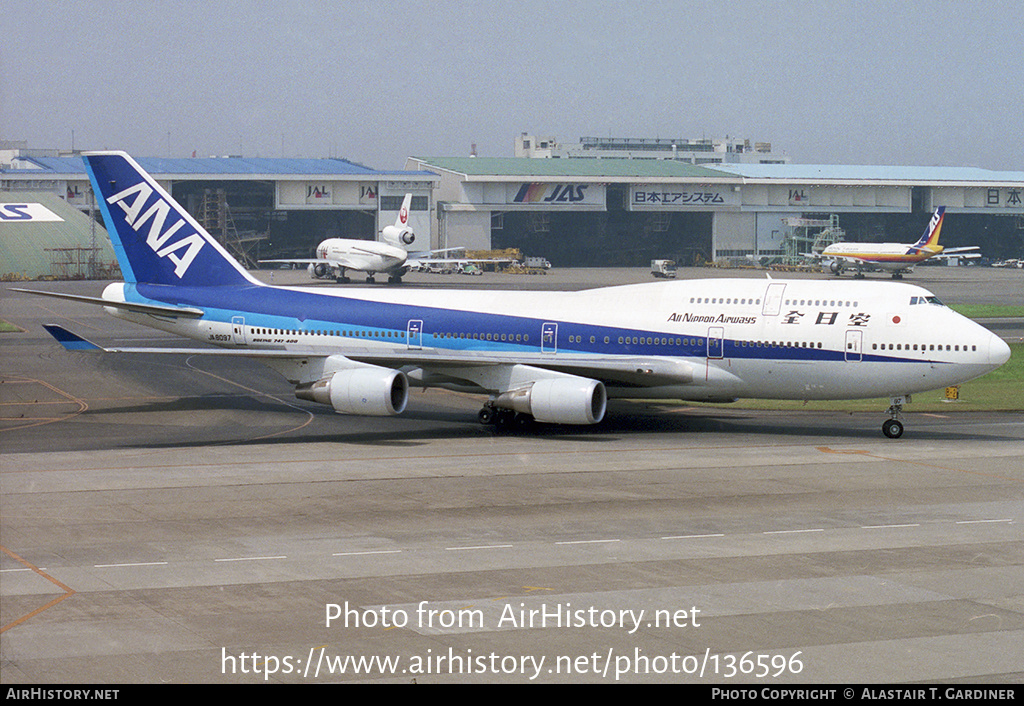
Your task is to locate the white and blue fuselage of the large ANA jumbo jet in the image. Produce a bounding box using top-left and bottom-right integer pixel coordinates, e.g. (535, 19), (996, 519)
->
(104, 279), (1009, 401)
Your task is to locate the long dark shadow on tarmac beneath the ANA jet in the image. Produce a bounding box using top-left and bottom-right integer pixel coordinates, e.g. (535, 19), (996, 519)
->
(77, 393), (1016, 448)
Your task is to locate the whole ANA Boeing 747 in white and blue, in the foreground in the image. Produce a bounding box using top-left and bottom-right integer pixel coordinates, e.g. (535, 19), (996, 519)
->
(19, 152), (1010, 438)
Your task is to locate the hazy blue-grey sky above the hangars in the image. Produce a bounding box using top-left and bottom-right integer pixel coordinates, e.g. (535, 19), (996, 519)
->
(0, 0), (1024, 171)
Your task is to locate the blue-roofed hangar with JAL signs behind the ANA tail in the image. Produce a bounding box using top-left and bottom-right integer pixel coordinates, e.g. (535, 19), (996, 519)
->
(0, 151), (439, 279)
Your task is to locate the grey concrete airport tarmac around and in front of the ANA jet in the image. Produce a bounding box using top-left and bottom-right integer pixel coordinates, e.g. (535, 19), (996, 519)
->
(0, 267), (1024, 687)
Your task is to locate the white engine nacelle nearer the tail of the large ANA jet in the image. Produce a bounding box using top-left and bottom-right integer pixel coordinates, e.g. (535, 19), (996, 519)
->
(295, 366), (409, 417)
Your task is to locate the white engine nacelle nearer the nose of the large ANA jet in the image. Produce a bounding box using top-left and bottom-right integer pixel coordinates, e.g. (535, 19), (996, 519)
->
(494, 377), (608, 424)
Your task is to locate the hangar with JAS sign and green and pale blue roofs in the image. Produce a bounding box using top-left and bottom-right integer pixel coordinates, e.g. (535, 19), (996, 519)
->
(406, 157), (1024, 266)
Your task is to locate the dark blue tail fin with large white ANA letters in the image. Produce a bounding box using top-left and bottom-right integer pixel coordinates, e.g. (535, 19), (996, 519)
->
(83, 152), (259, 287)
